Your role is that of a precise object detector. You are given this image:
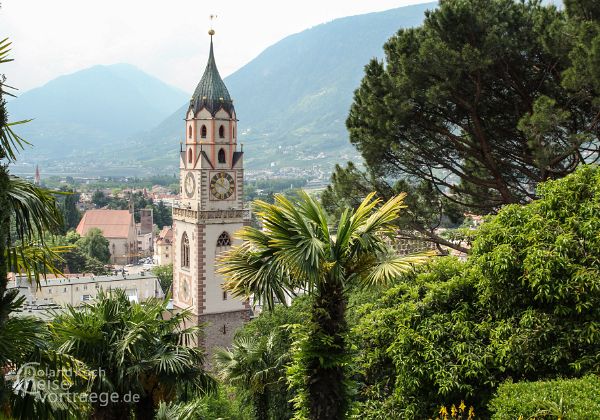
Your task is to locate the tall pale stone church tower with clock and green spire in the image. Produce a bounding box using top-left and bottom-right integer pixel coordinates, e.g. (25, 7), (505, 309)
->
(173, 29), (250, 354)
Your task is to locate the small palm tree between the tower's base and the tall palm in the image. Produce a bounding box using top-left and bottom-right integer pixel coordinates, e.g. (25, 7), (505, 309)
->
(214, 331), (288, 420)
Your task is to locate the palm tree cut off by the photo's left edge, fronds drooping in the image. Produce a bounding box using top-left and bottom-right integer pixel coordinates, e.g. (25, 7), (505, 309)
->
(0, 33), (71, 410)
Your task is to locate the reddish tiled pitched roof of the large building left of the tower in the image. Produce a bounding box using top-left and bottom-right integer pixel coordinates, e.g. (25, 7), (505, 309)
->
(77, 210), (134, 238)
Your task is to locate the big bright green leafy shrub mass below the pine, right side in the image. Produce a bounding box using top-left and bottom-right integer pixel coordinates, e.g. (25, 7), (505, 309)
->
(352, 166), (600, 418)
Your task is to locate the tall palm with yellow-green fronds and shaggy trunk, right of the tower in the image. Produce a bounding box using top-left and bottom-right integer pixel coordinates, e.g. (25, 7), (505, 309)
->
(219, 192), (426, 420)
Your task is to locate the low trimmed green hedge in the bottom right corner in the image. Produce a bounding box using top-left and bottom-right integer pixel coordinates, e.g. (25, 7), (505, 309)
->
(490, 375), (600, 420)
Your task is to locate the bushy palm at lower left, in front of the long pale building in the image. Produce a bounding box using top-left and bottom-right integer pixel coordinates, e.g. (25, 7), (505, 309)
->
(50, 289), (215, 419)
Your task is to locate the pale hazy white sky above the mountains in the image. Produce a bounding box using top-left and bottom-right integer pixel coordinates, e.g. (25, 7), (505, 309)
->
(0, 0), (431, 92)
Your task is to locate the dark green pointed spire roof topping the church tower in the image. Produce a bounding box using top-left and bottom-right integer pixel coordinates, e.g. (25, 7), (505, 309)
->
(190, 36), (233, 116)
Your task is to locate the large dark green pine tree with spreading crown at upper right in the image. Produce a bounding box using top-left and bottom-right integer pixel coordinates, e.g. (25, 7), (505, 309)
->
(347, 0), (600, 214)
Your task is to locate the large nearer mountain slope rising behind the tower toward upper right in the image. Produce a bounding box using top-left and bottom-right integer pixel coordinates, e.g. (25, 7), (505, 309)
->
(121, 3), (437, 176)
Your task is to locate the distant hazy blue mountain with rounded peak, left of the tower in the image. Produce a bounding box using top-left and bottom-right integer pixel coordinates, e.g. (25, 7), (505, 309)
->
(7, 64), (187, 162)
